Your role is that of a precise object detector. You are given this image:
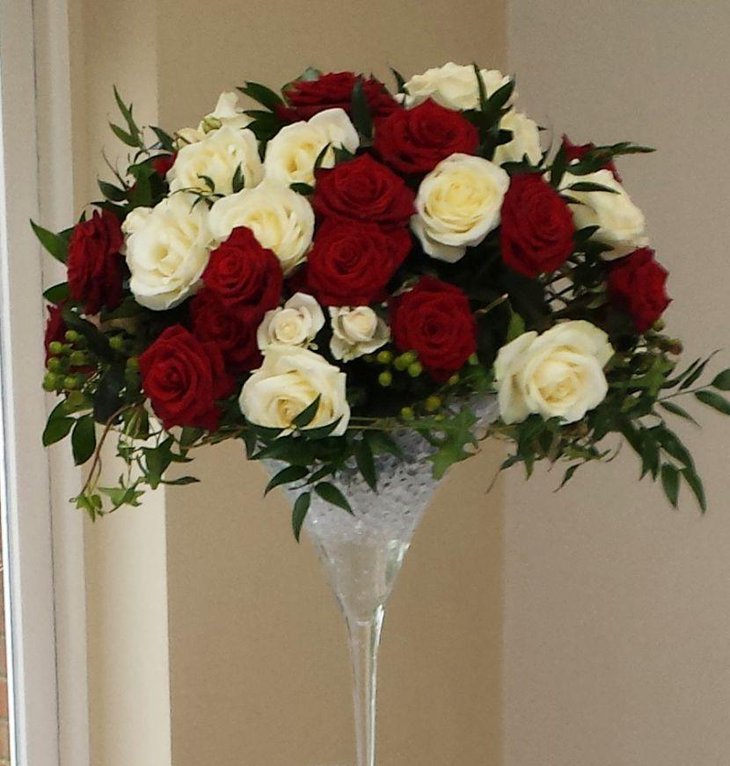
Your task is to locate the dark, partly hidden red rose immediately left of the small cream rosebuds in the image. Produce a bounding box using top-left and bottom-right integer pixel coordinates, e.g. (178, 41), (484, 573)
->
(190, 288), (263, 375)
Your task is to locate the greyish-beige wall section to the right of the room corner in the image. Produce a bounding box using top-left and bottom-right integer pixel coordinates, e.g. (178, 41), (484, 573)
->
(504, 0), (730, 766)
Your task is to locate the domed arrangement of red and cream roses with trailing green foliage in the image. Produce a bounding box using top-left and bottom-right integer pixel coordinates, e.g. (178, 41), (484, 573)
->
(33, 64), (730, 537)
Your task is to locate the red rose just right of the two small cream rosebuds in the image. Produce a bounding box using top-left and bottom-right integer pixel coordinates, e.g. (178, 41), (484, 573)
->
(391, 277), (477, 382)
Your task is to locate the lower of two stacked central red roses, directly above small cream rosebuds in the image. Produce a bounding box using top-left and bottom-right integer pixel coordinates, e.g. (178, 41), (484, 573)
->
(307, 220), (411, 306)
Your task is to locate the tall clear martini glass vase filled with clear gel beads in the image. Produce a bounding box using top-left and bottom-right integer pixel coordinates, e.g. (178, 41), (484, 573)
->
(272, 431), (437, 766)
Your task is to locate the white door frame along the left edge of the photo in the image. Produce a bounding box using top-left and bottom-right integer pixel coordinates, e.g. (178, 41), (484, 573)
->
(0, 0), (89, 766)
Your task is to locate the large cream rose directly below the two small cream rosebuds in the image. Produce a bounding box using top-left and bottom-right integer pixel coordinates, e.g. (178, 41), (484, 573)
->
(239, 345), (350, 436)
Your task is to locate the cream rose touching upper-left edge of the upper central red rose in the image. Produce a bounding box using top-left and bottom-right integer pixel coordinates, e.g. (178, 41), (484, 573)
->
(264, 109), (360, 186)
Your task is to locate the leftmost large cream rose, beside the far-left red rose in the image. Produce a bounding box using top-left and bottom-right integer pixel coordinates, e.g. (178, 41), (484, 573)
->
(122, 192), (213, 311)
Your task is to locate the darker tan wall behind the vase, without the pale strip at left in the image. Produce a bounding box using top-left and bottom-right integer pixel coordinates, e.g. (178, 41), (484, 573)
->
(158, 0), (505, 766)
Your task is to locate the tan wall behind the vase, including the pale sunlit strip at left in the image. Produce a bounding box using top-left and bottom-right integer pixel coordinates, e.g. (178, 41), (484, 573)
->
(72, 0), (506, 766)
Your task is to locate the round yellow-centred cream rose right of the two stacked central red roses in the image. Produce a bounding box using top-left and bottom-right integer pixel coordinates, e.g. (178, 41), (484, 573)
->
(411, 154), (509, 263)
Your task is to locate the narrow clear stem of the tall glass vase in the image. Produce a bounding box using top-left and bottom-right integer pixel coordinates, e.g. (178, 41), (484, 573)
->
(345, 604), (385, 766)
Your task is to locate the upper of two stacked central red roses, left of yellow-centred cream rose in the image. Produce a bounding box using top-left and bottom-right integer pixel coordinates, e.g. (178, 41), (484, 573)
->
(312, 154), (416, 226)
